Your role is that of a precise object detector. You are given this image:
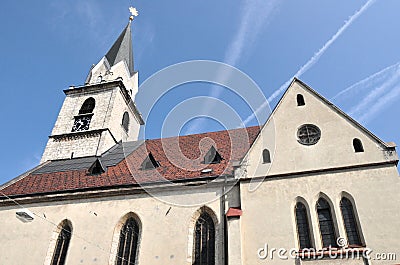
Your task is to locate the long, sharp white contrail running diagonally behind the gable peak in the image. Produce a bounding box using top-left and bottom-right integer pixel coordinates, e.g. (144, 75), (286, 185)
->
(244, 0), (376, 124)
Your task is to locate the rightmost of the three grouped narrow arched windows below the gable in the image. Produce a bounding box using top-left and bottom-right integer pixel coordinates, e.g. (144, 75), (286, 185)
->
(340, 197), (362, 246)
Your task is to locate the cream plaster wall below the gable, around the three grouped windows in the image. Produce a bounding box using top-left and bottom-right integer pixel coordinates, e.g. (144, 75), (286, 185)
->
(241, 165), (400, 265)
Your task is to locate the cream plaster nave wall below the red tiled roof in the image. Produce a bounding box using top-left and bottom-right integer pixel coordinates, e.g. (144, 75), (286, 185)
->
(0, 188), (223, 265)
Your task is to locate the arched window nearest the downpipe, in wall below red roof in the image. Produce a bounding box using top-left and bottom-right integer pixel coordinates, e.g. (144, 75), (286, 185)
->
(192, 212), (215, 265)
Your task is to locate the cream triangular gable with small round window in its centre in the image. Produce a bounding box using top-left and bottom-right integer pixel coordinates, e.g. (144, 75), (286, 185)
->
(242, 78), (398, 177)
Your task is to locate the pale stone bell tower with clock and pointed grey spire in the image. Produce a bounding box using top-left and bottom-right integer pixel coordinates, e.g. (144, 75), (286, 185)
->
(41, 14), (144, 163)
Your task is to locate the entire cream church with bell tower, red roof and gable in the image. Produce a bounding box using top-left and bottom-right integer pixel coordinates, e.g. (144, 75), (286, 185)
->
(0, 11), (400, 265)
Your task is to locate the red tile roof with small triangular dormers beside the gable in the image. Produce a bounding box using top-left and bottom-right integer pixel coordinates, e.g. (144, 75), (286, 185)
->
(1, 126), (260, 196)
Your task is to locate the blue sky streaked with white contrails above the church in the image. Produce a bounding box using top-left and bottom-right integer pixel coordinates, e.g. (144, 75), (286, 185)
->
(0, 0), (400, 182)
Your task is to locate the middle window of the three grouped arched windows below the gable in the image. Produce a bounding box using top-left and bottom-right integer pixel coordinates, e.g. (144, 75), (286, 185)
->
(317, 198), (337, 248)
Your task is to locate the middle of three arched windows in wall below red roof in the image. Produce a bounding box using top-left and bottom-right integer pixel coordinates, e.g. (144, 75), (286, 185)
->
(116, 217), (139, 265)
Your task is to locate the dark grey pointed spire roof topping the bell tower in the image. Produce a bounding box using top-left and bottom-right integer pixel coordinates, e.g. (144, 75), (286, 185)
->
(105, 21), (134, 76)
